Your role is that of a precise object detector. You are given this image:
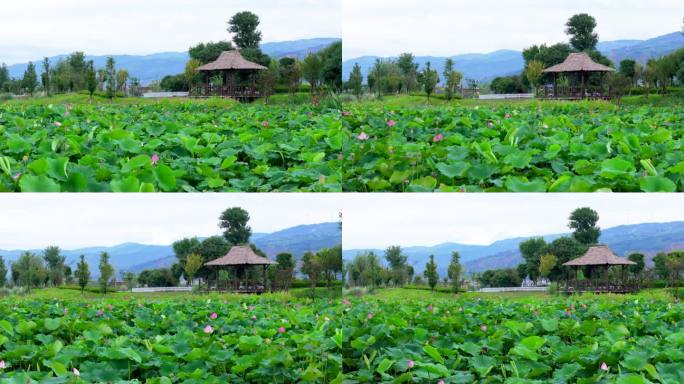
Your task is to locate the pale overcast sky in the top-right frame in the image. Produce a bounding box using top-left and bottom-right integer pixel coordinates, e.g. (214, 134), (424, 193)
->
(342, 0), (684, 60)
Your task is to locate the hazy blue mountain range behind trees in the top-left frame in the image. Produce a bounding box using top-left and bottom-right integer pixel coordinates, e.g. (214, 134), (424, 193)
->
(8, 37), (340, 84)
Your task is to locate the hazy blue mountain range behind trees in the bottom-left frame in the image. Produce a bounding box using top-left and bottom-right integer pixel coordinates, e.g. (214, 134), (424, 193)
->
(0, 222), (342, 277)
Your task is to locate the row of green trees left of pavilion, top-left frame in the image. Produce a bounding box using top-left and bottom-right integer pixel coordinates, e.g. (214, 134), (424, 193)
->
(0, 52), (140, 98)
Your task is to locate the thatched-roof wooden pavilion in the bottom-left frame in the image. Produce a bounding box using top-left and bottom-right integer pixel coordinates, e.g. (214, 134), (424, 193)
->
(204, 245), (277, 293)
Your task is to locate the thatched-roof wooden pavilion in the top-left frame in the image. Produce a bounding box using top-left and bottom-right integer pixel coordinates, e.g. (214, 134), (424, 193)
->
(190, 50), (267, 100)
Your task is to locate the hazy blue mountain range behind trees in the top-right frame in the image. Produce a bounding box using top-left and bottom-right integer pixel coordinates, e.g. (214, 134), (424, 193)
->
(342, 32), (684, 81)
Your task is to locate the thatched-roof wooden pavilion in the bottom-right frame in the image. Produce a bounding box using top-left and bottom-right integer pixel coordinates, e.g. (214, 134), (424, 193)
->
(560, 245), (640, 293)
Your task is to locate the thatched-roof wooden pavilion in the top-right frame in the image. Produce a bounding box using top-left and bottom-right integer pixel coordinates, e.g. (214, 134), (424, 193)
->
(539, 52), (615, 100)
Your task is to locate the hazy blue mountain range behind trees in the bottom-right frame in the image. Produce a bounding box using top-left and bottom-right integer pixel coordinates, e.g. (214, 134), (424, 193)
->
(342, 221), (684, 276)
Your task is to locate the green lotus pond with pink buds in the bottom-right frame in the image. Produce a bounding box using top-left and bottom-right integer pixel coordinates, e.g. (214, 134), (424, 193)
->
(343, 293), (684, 384)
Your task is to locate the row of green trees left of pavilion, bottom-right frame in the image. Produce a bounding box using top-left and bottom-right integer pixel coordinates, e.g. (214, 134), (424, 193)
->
(344, 245), (463, 292)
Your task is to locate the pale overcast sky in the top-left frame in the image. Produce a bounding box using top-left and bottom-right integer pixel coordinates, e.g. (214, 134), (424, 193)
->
(0, 0), (342, 64)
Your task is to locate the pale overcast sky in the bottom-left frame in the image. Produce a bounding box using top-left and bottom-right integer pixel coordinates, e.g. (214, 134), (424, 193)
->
(0, 193), (340, 249)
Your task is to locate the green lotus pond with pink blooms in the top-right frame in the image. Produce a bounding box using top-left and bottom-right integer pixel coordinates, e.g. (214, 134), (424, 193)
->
(344, 102), (684, 192)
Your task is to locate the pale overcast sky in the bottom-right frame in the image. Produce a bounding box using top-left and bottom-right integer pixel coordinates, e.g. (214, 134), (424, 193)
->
(342, 193), (684, 249)
